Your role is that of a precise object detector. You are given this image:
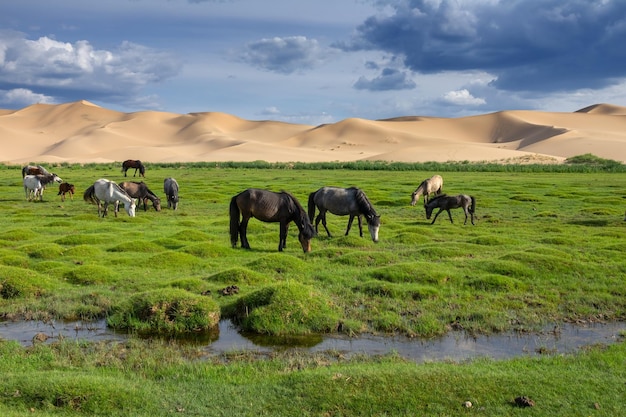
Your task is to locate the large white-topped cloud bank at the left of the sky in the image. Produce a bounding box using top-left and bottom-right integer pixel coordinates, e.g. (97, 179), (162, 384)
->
(0, 31), (181, 107)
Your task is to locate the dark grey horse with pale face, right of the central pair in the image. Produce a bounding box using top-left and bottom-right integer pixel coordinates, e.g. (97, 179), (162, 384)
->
(309, 187), (380, 242)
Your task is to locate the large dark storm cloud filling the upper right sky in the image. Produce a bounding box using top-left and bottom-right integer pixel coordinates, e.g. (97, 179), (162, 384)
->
(335, 0), (626, 91)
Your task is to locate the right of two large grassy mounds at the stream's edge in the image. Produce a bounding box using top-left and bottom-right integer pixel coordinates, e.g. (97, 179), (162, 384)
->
(233, 282), (339, 335)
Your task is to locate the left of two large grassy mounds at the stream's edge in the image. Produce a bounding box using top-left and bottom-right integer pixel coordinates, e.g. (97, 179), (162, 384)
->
(107, 288), (220, 334)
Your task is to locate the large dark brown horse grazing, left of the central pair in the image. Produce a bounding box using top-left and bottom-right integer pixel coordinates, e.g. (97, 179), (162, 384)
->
(230, 188), (315, 253)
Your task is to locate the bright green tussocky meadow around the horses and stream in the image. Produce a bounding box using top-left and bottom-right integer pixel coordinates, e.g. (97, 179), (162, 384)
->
(0, 164), (626, 416)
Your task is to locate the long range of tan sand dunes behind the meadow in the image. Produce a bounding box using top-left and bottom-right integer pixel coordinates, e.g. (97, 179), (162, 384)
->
(0, 101), (626, 164)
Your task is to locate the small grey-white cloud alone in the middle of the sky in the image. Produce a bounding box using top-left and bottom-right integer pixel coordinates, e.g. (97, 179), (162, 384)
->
(239, 36), (329, 74)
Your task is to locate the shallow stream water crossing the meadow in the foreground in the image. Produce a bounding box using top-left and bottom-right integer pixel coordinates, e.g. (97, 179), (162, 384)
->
(0, 320), (626, 362)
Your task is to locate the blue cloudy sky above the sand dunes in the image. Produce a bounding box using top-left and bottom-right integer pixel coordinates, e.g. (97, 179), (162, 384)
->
(0, 0), (626, 125)
